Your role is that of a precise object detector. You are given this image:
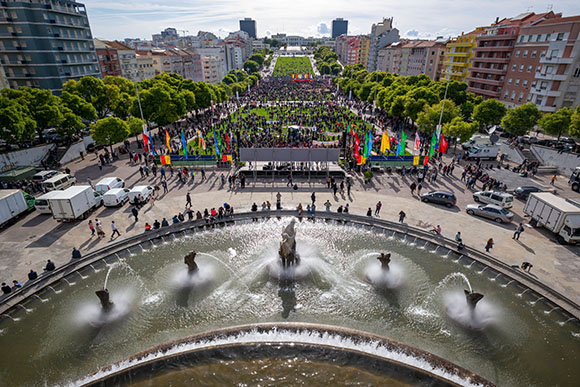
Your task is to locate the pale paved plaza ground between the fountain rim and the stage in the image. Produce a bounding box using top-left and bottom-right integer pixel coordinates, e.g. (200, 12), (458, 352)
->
(0, 147), (580, 303)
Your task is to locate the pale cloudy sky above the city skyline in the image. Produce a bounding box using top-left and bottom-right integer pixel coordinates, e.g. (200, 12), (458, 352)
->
(84, 0), (580, 40)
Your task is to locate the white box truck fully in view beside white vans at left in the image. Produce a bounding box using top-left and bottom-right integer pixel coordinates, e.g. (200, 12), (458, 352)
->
(48, 185), (99, 222)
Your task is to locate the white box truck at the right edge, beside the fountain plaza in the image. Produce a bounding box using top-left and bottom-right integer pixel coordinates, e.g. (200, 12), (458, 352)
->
(524, 192), (580, 244)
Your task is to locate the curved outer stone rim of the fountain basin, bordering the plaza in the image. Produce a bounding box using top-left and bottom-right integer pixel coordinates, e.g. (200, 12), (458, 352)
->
(0, 210), (580, 319)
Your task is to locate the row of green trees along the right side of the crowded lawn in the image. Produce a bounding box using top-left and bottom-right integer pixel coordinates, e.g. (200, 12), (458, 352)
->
(334, 65), (580, 141)
